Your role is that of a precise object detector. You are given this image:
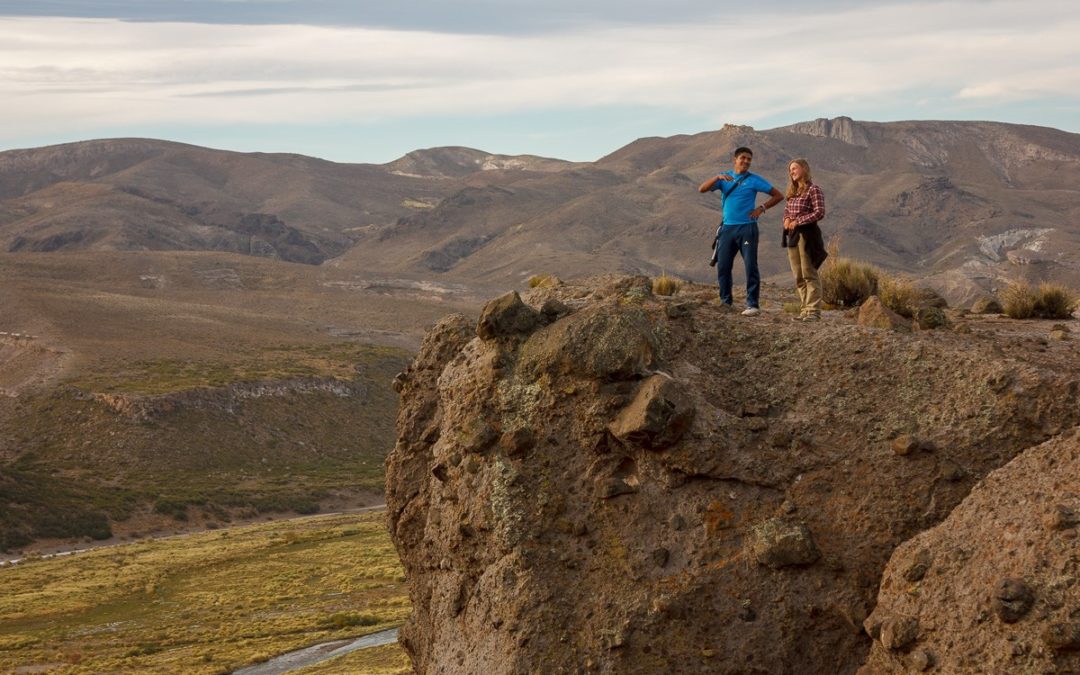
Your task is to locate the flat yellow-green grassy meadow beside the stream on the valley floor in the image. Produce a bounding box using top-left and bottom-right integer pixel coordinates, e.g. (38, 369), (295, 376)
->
(0, 513), (409, 675)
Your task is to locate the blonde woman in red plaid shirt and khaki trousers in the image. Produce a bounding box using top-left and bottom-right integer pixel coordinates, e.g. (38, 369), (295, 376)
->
(783, 159), (828, 322)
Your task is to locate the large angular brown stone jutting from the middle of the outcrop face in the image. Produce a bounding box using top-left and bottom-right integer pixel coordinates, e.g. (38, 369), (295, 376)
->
(608, 375), (694, 449)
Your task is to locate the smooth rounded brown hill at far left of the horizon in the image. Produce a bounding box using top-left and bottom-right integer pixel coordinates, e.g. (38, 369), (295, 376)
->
(0, 139), (445, 264)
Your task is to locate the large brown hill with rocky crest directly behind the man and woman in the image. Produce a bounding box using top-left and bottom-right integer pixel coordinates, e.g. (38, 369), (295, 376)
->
(354, 119), (1080, 301)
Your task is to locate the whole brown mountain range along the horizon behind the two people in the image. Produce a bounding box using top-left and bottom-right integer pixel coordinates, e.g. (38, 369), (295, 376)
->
(0, 118), (1080, 302)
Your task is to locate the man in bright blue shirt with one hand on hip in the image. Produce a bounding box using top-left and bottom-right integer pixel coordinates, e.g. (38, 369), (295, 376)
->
(698, 148), (784, 316)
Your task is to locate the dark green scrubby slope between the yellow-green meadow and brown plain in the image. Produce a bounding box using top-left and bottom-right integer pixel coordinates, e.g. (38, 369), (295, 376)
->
(0, 343), (407, 550)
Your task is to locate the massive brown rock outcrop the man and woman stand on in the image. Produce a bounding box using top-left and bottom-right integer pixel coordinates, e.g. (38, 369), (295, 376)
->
(387, 278), (1080, 674)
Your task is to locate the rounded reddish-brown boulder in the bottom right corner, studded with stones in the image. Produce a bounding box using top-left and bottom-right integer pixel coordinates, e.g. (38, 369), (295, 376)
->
(864, 429), (1080, 674)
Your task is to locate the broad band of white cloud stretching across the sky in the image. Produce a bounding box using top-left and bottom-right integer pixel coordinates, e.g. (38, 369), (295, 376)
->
(0, 0), (1080, 153)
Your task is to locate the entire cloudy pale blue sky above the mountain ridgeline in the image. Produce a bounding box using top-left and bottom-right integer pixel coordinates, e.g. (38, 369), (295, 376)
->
(0, 0), (1080, 163)
